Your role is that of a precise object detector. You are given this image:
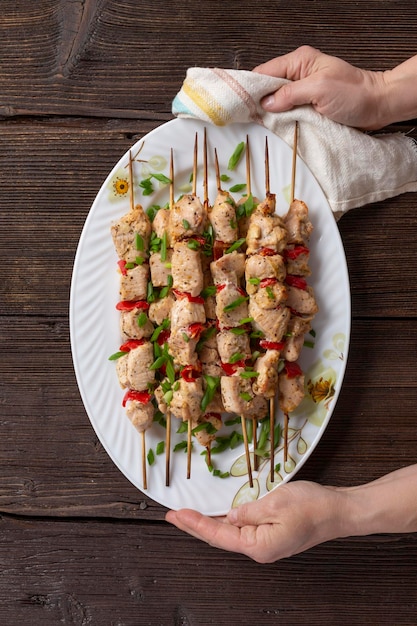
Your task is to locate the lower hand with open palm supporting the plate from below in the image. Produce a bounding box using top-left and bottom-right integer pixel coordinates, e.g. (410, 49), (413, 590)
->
(166, 481), (344, 563)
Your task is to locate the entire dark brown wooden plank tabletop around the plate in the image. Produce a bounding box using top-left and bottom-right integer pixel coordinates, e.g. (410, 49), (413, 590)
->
(0, 0), (417, 626)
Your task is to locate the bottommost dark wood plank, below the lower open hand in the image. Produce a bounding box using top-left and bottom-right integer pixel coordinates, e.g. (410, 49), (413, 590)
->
(0, 516), (417, 626)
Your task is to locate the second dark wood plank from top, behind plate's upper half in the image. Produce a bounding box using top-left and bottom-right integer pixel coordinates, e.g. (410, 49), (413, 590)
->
(0, 120), (417, 317)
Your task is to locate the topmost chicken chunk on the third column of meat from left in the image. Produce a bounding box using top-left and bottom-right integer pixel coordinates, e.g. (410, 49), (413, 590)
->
(169, 194), (206, 242)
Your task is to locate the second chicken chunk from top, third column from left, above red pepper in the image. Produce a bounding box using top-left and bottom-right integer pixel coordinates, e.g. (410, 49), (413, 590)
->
(171, 241), (204, 296)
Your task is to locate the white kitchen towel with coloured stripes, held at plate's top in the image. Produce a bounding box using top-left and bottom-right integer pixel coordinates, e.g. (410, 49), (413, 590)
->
(172, 67), (417, 217)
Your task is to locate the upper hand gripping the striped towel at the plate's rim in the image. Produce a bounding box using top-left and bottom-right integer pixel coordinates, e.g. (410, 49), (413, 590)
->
(253, 46), (391, 130)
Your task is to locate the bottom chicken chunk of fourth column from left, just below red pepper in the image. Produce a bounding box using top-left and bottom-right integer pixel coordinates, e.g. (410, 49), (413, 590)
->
(220, 375), (268, 419)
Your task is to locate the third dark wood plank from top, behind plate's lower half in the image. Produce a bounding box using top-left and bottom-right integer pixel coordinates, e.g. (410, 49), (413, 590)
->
(0, 316), (417, 519)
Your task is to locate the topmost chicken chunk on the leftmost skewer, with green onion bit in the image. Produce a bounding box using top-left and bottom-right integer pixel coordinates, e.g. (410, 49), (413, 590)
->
(111, 204), (152, 263)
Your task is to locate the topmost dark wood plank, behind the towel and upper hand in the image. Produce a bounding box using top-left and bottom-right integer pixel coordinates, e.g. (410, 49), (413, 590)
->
(0, 0), (417, 118)
